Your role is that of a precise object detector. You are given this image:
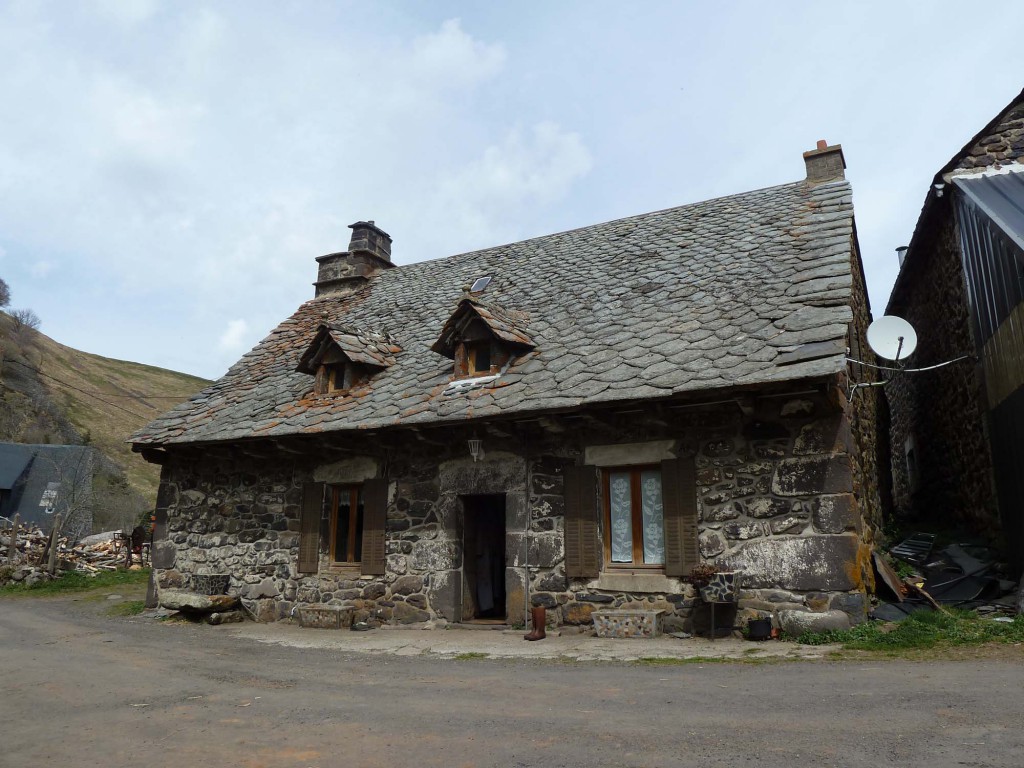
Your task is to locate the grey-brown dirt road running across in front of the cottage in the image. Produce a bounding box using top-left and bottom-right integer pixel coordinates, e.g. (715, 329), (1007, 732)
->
(0, 596), (1024, 768)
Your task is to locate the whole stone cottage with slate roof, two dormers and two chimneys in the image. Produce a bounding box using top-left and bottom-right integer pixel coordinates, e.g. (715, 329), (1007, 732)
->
(132, 141), (881, 628)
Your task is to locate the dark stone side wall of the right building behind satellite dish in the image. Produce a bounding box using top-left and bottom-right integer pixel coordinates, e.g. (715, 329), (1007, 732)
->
(886, 204), (999, 539)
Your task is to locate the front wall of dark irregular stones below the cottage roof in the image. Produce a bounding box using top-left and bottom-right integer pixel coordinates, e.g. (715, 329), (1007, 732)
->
(157, 388), (871, 629)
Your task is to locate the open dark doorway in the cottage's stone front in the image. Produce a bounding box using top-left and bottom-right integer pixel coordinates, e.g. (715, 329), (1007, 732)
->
(462, 494), (505, 622)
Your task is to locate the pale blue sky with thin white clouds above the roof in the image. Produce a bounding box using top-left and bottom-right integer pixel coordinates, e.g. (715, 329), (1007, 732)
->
(0, 0), (1024, 378)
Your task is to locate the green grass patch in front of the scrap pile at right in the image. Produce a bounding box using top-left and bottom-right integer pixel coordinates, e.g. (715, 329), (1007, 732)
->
(796, 609), (1024, 651)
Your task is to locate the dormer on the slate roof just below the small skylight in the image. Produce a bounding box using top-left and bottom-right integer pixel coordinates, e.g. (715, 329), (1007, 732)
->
(431, 297), (534, 379)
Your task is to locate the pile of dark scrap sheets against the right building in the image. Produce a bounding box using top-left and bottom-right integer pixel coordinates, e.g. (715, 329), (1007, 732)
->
(870, 534), (1017, 622)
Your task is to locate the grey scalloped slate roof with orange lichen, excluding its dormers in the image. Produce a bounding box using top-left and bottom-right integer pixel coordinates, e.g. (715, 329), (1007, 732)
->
(131, 180), (853, 445)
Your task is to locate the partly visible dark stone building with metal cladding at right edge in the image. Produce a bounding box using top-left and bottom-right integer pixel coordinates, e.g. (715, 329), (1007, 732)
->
(886, 92), (1024, 568)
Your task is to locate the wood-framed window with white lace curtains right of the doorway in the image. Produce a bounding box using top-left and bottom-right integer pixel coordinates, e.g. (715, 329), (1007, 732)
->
(603, 466), (665, 569)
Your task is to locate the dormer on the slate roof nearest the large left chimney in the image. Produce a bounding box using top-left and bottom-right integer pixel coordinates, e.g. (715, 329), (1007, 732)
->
(295, 325), (401, 395)
